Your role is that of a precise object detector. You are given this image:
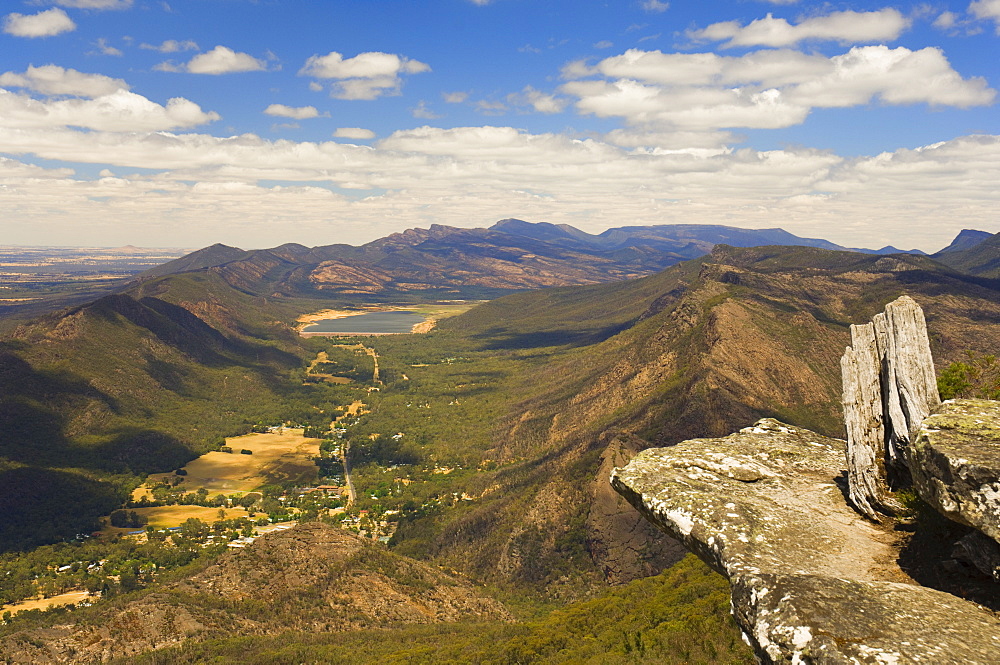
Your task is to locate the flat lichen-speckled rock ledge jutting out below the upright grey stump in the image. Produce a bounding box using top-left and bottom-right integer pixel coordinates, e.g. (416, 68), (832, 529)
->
(611, 419), (1000, 664)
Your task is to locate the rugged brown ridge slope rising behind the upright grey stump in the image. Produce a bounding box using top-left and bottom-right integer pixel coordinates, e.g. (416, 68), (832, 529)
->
(398, 246), (1000, 587)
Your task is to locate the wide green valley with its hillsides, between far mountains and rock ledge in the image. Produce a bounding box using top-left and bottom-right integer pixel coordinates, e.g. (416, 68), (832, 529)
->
(0, 222), (1000, 663)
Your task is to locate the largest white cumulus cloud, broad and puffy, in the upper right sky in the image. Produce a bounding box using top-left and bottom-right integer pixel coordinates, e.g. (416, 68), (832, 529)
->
(560, 46), (996, 132)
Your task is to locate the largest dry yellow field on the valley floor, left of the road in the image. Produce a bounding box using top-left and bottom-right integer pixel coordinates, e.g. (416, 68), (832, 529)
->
(136, 429), (320, 496)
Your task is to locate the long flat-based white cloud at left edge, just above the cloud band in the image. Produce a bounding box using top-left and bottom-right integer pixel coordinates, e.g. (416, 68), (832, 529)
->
(0, 89), (219, 132)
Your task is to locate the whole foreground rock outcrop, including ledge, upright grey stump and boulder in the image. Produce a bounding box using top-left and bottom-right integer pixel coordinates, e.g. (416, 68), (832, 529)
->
(612, 299), (1000, 663)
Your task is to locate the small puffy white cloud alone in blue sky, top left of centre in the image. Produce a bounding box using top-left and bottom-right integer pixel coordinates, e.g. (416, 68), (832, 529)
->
(299, 51), (431, 100)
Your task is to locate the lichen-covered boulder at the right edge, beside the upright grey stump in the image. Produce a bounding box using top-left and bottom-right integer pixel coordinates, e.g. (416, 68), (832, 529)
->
(910, 399), (1000, 542)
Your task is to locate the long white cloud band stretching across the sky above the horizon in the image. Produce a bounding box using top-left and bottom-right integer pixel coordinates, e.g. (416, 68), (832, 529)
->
(0, 121), (1000, 250)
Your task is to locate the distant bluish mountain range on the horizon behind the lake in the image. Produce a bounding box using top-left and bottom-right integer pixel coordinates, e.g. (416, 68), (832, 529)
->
(140, 219), (936, 300)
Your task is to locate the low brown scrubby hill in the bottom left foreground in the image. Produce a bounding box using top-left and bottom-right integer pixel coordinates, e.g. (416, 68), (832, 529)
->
(0, 522), (510, 663)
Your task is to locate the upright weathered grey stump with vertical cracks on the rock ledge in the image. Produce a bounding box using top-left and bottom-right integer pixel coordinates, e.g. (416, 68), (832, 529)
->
(840, 296), (940, 520)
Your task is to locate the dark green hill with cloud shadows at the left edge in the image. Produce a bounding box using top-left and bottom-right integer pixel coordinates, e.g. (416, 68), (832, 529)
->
(0, 273), (318, 549)
